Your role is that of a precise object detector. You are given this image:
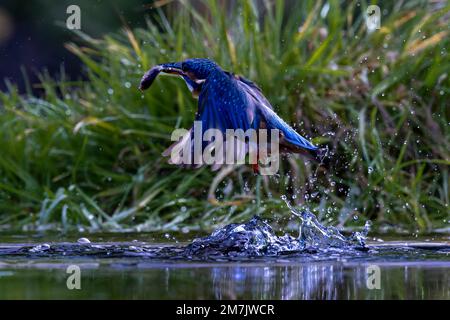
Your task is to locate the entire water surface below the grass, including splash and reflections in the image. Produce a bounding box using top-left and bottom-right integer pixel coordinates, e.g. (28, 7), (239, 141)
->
(0, 208), (450, 299)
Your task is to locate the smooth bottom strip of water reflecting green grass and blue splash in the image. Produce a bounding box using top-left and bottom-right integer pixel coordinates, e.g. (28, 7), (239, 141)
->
(0, 263), (450, 299)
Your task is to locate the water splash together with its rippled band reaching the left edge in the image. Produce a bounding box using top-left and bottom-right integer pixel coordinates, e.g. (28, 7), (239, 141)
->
(7, 196), (370, 261)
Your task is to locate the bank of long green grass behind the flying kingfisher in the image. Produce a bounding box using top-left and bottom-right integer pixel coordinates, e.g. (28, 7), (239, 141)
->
(0, 1), (450, 232)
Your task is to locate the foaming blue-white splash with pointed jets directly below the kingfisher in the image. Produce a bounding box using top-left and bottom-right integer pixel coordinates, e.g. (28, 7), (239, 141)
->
(184, 196), (371, 257)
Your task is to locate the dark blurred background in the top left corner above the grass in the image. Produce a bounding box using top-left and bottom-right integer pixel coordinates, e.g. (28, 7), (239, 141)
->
(0, 0), (153, 92)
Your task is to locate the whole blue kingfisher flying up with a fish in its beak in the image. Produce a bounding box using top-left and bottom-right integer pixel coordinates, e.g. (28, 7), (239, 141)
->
(139, 58), (326, 173)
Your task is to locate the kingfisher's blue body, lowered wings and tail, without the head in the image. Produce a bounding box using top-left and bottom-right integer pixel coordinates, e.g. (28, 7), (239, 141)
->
(164, 72), (318, 169)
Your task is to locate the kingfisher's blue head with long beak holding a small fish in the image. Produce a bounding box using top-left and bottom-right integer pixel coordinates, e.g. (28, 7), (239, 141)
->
(139, 58), (220, 90)
